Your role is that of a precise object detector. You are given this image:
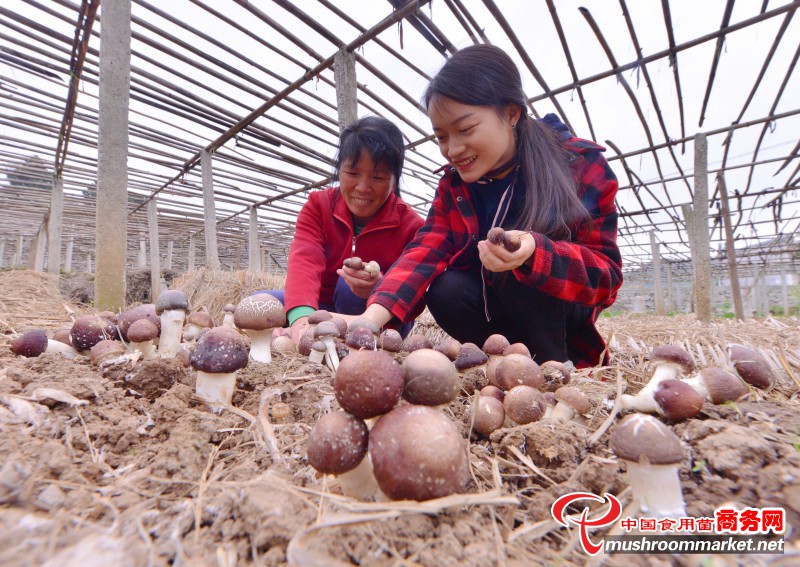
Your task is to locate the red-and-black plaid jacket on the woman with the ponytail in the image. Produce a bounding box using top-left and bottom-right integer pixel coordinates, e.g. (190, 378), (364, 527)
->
(368, 137), (622, 366)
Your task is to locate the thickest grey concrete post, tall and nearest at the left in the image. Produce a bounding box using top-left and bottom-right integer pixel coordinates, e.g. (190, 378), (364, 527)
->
(94, 0), (131, 311)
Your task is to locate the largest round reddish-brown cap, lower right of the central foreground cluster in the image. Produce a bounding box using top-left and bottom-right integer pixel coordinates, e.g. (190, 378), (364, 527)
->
(369, 405), (469, 501)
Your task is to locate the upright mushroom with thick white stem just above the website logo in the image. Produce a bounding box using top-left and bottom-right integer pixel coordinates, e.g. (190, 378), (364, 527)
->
(609, 413), (686, 518)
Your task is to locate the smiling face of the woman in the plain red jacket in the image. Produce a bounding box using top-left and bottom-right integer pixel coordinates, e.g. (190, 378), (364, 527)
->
(339, 151), (396, 226)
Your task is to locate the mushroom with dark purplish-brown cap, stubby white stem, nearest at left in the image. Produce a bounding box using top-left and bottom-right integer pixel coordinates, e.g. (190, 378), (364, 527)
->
(189, 326), (248, 411)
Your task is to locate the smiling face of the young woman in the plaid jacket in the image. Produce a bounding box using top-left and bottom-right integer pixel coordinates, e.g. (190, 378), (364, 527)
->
(428, 96), (520, 183)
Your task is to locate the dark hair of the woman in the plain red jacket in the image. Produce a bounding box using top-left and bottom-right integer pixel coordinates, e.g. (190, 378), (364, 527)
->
(333, 116), (406, 196)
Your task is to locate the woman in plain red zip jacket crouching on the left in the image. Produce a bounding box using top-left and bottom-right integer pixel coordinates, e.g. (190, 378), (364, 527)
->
(280, 116), (423, 340)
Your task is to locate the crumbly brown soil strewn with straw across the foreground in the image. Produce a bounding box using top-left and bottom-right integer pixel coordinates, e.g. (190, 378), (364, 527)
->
(0, 272), (800, 567)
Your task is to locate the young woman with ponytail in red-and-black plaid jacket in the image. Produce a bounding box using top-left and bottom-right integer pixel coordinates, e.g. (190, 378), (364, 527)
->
(364, 45), (622, 367)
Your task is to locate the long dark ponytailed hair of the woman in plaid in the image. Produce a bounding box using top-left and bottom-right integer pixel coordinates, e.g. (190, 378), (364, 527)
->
(423, 45), (590, 239)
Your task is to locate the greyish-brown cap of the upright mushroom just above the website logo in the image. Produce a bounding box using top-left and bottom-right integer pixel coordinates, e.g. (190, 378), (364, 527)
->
(608, 413), (683, 465)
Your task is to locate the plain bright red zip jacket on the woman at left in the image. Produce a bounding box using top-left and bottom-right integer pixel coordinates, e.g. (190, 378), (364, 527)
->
(285, 187), (423, 312)
